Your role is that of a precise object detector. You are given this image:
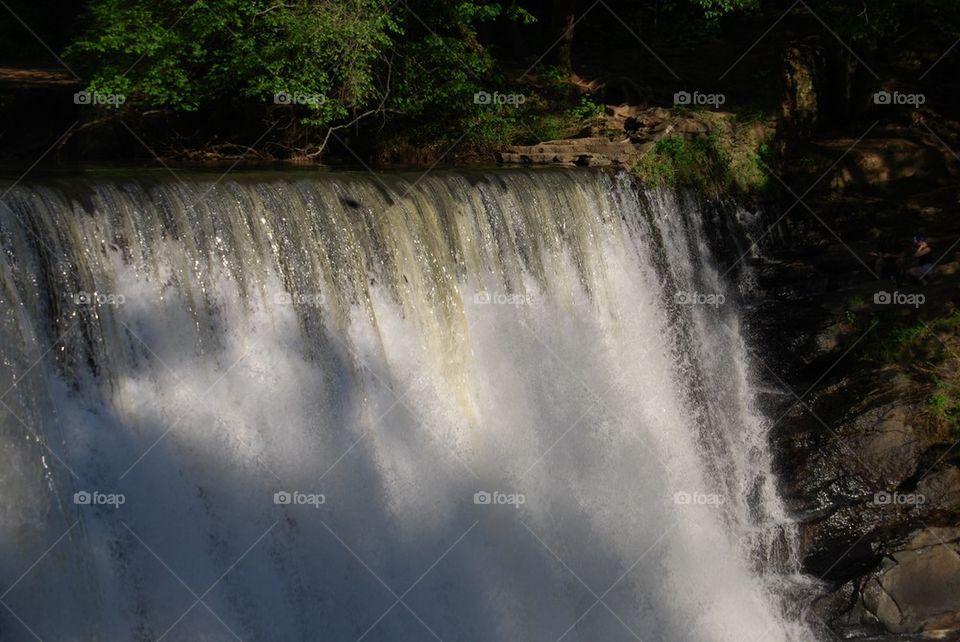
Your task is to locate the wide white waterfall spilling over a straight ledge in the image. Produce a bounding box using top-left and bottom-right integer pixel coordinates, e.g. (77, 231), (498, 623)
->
(0, 170), (810, 642)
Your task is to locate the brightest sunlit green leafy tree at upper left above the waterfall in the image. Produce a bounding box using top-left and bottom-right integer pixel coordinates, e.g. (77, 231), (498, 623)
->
(67, 0), (401, 124)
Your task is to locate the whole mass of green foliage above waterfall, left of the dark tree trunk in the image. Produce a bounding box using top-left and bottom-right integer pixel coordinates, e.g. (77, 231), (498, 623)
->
(66, 0), (548, 140)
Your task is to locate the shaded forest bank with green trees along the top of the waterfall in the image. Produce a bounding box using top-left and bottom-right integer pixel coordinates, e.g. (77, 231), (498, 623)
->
(0, 0), (960, 162)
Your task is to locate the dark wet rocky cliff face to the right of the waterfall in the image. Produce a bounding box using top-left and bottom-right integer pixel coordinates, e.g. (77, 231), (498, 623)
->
(753, 219), (960, 640)
